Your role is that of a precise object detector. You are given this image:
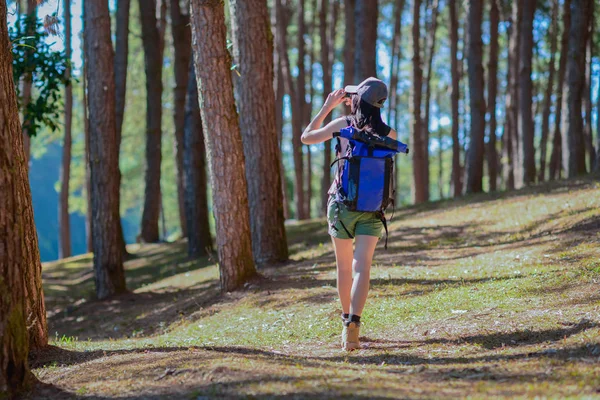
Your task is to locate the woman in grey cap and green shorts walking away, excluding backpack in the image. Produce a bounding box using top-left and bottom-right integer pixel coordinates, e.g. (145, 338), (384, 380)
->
(302, 78), (397, 350)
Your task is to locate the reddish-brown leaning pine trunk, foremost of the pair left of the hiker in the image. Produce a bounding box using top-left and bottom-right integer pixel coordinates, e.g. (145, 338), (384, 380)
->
(190, 0), (255, 291)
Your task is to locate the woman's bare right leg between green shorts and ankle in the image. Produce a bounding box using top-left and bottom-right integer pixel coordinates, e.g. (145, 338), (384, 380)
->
(344, 235), (379, 316)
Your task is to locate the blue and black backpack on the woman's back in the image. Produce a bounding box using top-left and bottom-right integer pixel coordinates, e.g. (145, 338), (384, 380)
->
(331, 126), (408, 249)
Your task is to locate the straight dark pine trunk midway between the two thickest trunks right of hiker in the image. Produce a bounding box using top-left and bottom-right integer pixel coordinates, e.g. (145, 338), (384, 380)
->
(516, 0), (536, 188)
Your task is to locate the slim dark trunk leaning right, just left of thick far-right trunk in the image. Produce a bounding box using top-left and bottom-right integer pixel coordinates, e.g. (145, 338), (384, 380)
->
(550, 0), (571, 180)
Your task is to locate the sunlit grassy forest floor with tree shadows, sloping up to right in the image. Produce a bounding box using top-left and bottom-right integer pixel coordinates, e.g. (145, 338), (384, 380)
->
(23, 179), (600, 399)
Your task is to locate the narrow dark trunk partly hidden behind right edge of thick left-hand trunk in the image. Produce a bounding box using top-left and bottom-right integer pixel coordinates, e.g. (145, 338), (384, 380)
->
(115, 0), (131, 256)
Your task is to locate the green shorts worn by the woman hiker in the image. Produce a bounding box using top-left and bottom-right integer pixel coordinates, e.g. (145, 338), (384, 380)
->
(327, 198), (383, 239)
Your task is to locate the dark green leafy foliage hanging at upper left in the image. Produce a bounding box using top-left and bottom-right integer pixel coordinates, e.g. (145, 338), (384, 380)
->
(9, 15), (70, 136)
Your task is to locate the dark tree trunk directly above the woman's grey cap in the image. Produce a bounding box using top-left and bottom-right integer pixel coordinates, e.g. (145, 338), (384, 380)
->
(354, 0), (378, 84)
